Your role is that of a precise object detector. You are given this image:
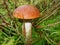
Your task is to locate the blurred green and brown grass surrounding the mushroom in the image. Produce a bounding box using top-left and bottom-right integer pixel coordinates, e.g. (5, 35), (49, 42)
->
(0, 0), (60, 45)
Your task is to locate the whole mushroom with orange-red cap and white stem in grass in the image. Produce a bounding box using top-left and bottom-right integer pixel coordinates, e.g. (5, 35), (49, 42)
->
(13, 5), (40, 45)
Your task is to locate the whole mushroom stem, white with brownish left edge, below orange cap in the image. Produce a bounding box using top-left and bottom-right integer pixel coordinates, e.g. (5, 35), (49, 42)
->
(22, 22), (32, 45)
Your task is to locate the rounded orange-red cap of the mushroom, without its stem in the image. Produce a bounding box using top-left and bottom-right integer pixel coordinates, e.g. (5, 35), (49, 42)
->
(13, 5), (40, 19)
